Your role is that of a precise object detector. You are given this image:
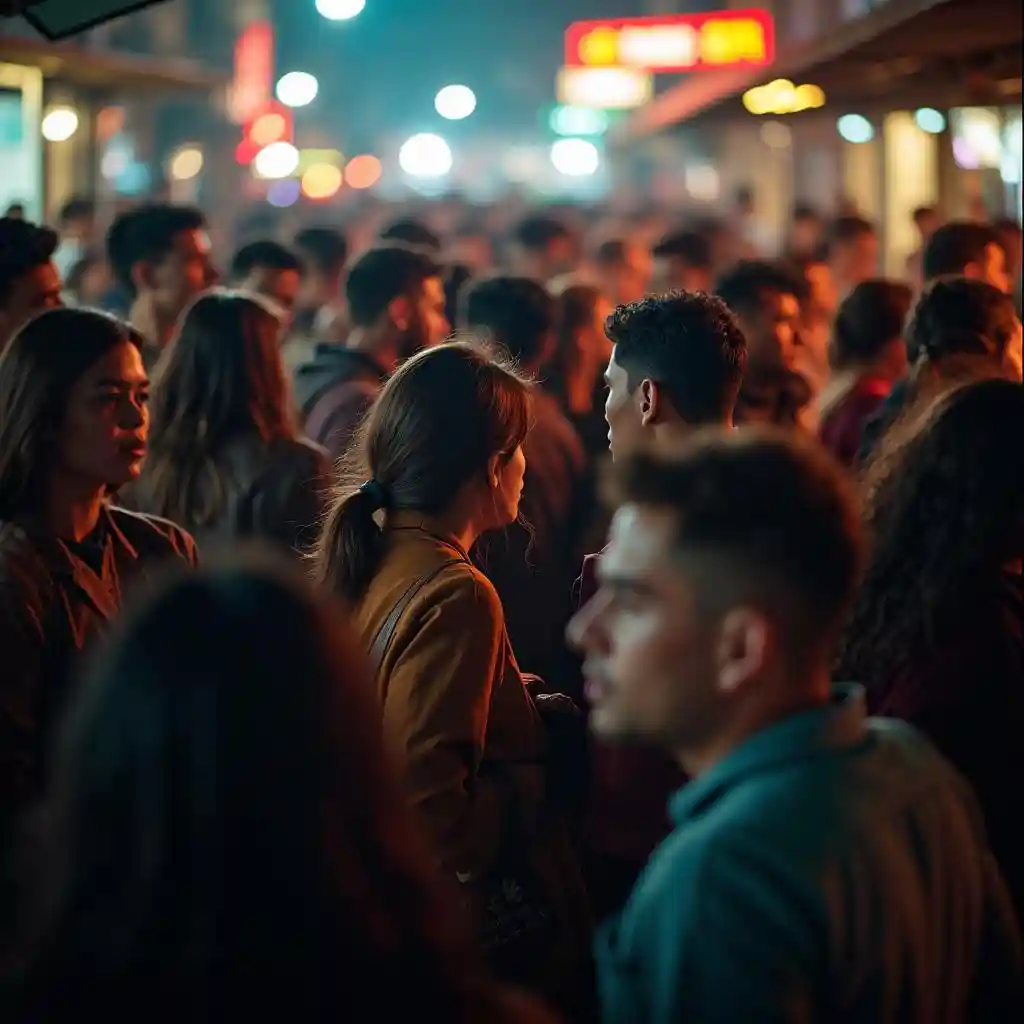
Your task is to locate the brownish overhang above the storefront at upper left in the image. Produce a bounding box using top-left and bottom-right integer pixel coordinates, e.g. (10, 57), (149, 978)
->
(0, 32), (229, 94)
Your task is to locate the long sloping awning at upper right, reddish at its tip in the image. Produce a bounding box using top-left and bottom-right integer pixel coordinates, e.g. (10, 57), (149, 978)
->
(611, 0), (1024, 142)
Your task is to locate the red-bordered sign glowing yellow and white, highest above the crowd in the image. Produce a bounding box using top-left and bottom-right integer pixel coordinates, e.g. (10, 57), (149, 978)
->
(565, 8), (775, 74)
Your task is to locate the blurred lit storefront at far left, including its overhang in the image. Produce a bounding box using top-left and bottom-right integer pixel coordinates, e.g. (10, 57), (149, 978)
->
(0, 29), (226, 220)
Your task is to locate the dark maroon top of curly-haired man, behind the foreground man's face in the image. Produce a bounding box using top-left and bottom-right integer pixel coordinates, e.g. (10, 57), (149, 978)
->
(580, 555), (686, 863)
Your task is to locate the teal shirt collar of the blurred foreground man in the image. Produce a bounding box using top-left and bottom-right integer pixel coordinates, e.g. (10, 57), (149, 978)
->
(669, 683), (867, 824)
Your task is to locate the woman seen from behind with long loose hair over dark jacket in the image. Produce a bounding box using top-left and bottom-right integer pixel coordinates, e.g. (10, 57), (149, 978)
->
(127, 291), (331, 551)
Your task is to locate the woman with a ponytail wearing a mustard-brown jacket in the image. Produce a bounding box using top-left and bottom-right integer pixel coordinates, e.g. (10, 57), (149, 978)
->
(316, 343), (590, 996)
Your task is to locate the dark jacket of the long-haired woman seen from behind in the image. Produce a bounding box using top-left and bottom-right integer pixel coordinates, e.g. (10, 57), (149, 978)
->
(124, 436), (332, 552)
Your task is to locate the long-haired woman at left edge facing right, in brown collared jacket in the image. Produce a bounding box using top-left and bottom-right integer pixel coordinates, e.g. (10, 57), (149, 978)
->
(0, 309), (196, 847)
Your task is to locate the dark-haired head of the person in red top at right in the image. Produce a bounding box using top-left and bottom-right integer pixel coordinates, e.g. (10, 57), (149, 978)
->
(828, 279), (913, 370)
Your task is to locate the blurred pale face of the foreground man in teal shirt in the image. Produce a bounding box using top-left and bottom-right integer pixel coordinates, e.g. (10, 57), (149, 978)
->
(568, 505), (720, 752)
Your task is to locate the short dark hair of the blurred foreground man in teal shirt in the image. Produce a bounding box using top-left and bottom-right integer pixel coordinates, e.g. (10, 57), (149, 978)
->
(606, 428), (864, 657)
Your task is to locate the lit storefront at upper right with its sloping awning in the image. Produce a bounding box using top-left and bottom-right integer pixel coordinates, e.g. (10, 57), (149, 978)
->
(614, 0), (1024, 272)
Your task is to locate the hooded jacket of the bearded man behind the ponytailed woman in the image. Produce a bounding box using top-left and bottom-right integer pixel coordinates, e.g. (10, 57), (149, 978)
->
(294, 344), (388, 459)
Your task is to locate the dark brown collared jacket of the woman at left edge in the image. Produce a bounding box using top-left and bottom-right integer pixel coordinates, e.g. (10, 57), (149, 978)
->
(0, 507), (198, 829)
